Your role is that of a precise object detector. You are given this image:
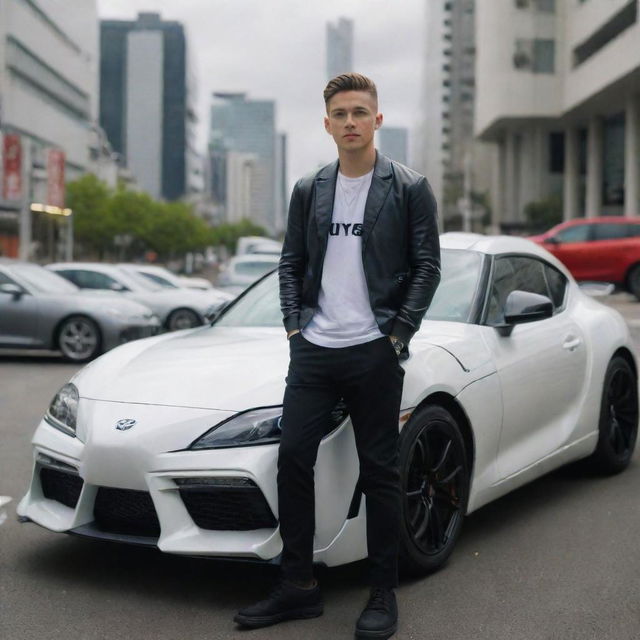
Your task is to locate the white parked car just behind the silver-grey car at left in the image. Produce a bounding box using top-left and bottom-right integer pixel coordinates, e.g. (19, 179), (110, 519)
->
(47, 262), (233, 331)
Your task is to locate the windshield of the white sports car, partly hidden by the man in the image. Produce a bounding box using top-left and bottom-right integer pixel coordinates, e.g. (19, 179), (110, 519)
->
(216, 249), (482, 327)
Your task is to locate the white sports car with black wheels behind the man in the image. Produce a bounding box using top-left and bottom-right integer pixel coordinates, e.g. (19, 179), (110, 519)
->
(18, 234), (638, 572)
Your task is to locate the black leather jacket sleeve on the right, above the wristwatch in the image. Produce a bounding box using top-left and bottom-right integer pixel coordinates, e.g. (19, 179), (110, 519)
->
(391, 177), (440, 342)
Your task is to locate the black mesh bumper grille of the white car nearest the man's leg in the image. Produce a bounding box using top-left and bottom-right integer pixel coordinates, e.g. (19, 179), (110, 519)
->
(180, 481), (278, 531)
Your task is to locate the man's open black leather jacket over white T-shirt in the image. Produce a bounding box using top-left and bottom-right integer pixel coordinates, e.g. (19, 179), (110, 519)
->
(279, 153), (440, 343)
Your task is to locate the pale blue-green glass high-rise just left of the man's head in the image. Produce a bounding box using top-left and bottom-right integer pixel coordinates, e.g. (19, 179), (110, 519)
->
(209, 93), (277, 233)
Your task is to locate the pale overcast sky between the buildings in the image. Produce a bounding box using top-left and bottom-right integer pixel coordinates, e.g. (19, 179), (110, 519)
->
(98, 0), (426, 190)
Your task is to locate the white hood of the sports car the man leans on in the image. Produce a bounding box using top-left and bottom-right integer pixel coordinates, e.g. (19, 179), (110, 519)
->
(73, 323), (489, 411)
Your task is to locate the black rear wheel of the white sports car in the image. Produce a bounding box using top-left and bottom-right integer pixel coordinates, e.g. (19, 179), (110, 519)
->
(588, 356), (638, 475)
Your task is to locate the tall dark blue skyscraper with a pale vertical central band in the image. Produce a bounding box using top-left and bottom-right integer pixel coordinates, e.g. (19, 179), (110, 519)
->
(100, 13), (202, 200)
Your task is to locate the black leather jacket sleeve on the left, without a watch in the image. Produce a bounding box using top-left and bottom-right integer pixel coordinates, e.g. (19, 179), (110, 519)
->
(278, 183), (305, 331)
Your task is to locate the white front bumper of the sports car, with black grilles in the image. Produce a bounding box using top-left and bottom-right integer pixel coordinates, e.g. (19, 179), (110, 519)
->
(17, 399), (366, 565)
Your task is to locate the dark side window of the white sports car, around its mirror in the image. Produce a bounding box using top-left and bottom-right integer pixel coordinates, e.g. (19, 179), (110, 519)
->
(486, 256), (566, 325)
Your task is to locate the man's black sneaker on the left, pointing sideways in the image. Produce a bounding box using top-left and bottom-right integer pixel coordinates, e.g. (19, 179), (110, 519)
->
(233, 582), (322, 629)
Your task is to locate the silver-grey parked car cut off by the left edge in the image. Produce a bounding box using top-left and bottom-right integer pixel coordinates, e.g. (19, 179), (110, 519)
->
(0, 258), (160, 362)
